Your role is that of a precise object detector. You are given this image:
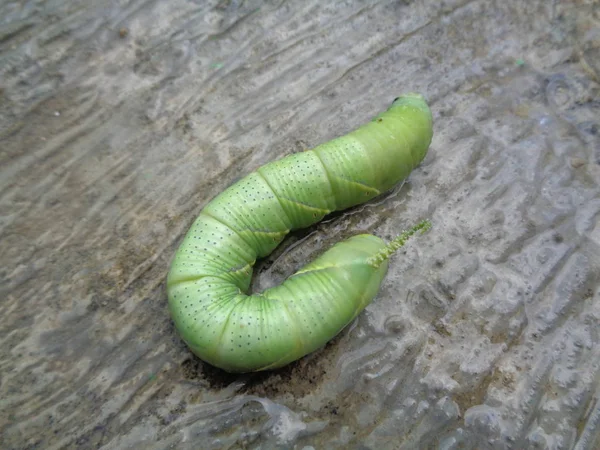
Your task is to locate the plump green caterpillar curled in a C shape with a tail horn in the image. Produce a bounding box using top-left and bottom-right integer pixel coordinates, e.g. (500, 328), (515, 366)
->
(167, 94), (433, 372)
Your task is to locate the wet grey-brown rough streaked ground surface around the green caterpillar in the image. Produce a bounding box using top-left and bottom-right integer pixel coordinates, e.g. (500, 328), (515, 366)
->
(0, 0), (600, 450)
